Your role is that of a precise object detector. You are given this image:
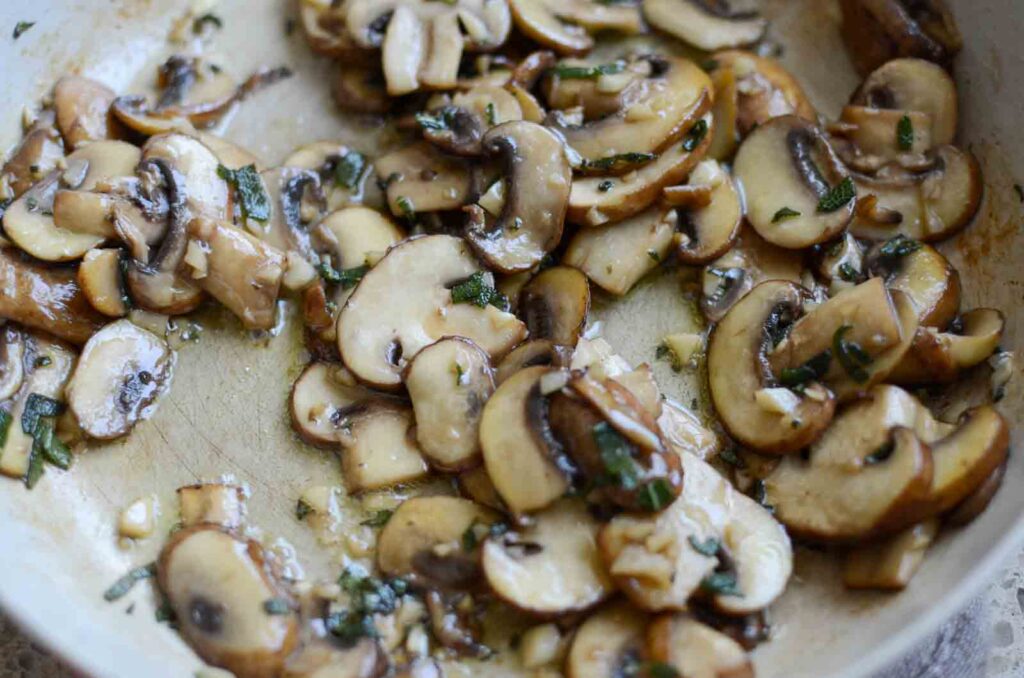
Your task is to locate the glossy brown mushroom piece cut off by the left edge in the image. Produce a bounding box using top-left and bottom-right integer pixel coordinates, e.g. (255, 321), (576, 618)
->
(0, 247), (106, 345)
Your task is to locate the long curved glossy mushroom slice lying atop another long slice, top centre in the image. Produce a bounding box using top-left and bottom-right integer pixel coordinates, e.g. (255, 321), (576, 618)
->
(549, 57), (712, 164)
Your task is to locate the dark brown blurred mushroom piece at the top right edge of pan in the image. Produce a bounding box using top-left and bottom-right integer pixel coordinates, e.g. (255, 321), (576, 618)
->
(840, 0), (964, 75)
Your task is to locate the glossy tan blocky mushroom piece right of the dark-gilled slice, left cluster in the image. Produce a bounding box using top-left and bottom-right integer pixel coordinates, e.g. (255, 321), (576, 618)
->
(184, 219), (285, 330)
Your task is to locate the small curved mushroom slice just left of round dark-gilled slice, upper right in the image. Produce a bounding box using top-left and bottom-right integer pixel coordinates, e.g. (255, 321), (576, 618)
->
(664, 160), (743, 265)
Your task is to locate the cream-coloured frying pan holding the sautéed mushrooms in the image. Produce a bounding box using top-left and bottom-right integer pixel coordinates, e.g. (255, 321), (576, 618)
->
(0, 0), (1024, 678)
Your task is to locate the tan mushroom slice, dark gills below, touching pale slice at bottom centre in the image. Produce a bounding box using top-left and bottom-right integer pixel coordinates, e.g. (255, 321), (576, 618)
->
(377, 497), (499, 591)
